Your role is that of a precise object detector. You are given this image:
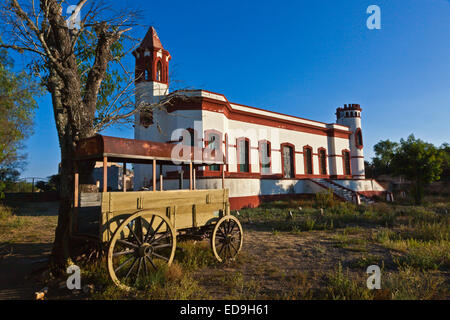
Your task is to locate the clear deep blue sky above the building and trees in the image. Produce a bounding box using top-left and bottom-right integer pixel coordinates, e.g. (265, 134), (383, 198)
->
(14, 0), (450, 177)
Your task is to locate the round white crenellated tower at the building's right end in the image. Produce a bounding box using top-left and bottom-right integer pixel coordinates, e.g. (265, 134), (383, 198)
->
(336, 104), (365, 179)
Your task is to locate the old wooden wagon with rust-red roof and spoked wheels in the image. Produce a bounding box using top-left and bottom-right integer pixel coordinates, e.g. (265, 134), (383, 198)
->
(71, 135), (243, 290)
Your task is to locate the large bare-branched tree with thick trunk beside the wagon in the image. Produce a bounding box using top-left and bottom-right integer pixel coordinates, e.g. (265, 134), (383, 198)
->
(0, 0), (179, 271)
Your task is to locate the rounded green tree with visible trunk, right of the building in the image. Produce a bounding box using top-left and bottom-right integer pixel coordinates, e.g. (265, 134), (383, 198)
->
(389, 134), (444, 204)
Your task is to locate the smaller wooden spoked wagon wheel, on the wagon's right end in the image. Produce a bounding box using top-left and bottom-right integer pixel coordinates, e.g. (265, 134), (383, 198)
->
(211, 215), (244, 262)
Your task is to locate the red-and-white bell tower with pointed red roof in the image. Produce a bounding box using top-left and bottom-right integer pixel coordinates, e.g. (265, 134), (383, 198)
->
(133, 27), (171, 129)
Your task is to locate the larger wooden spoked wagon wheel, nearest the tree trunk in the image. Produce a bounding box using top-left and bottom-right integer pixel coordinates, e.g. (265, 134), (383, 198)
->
(108, 211), (176, 290)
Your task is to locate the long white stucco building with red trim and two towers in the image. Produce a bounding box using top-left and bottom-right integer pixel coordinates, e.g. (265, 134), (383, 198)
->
(133, 27), (385, 209)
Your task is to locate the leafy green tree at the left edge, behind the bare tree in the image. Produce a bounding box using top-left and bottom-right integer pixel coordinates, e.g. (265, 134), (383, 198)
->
(0, 39), (42, 197)
